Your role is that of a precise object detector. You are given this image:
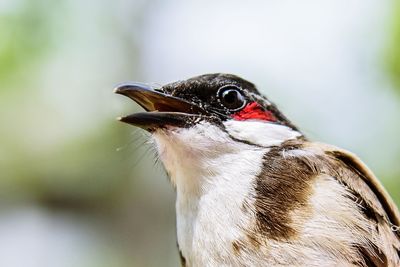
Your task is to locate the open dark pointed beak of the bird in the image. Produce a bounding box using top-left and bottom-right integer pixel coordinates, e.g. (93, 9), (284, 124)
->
(114, 83), (207, 130)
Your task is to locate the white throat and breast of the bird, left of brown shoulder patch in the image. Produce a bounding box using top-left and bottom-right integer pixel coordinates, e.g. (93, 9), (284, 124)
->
(154, 122), (300, 266)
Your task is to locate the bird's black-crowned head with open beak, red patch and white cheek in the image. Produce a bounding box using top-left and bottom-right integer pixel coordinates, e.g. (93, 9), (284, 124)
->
(115, 74), (302, 187)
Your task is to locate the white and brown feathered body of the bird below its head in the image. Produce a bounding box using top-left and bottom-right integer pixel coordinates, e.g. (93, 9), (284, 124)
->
(154, 123), (400, 267)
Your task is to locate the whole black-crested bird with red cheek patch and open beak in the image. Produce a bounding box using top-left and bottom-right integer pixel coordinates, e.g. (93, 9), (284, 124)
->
(115, 73), (400, 267)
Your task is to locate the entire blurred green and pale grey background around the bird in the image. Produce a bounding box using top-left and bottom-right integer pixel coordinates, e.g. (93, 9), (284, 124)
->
(0, 0), (400, 267)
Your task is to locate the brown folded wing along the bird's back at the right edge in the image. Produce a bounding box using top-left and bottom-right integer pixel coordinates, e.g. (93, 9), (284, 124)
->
(307, 143), (400, 266)
